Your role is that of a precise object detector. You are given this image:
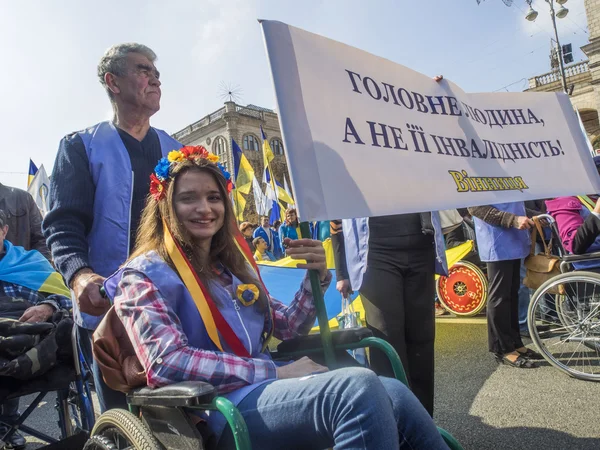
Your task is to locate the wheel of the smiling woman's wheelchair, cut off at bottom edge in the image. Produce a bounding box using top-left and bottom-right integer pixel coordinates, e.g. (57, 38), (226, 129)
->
(84, 409), (162, 450)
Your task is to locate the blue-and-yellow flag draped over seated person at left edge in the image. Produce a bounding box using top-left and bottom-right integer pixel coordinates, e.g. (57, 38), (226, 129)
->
(0, 240), (71, 297)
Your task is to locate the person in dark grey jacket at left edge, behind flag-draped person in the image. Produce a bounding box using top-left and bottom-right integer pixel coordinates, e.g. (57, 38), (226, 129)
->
(0, 183), (50, 260)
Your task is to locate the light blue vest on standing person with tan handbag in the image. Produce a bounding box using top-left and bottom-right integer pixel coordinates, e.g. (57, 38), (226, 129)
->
(473, 202), (531, 262)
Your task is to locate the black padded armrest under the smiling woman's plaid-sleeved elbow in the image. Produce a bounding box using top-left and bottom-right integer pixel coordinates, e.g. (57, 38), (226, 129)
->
(127, 381), (217, 407)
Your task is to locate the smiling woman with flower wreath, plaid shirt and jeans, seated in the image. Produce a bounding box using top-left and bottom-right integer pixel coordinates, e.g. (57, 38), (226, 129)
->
(99, 147), (447, 450)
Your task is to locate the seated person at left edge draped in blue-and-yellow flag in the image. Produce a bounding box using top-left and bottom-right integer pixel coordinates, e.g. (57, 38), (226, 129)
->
(0, 209), (71, 449)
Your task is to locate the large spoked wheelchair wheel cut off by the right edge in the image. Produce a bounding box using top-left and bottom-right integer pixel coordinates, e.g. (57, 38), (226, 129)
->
(527, 272), (600, 381)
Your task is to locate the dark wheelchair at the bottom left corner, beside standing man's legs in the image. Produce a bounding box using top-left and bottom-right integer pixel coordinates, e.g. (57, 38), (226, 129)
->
(0, 325), (95, 449)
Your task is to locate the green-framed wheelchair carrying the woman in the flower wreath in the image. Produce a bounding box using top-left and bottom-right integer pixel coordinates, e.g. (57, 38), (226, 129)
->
(84, 222), (462, 450)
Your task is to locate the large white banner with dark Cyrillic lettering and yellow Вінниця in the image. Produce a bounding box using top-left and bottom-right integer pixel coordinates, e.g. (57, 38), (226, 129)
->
(261, 21), (600, 220)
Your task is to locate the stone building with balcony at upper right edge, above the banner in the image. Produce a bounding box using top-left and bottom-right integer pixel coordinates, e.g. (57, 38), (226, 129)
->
(527, 0), (600, 149)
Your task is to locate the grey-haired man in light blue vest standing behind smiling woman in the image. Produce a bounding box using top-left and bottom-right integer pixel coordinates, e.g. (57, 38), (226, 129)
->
(43, 44), (181, 411)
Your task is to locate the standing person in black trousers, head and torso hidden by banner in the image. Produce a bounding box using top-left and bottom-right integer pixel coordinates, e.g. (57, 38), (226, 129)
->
(331, 213), (443, 414)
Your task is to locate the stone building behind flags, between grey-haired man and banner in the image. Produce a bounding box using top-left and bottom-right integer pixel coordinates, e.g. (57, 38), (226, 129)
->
(173, 102), (289, 223)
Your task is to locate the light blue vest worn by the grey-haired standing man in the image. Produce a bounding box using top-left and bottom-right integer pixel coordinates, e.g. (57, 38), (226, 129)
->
(73, 122), (182, 330)
